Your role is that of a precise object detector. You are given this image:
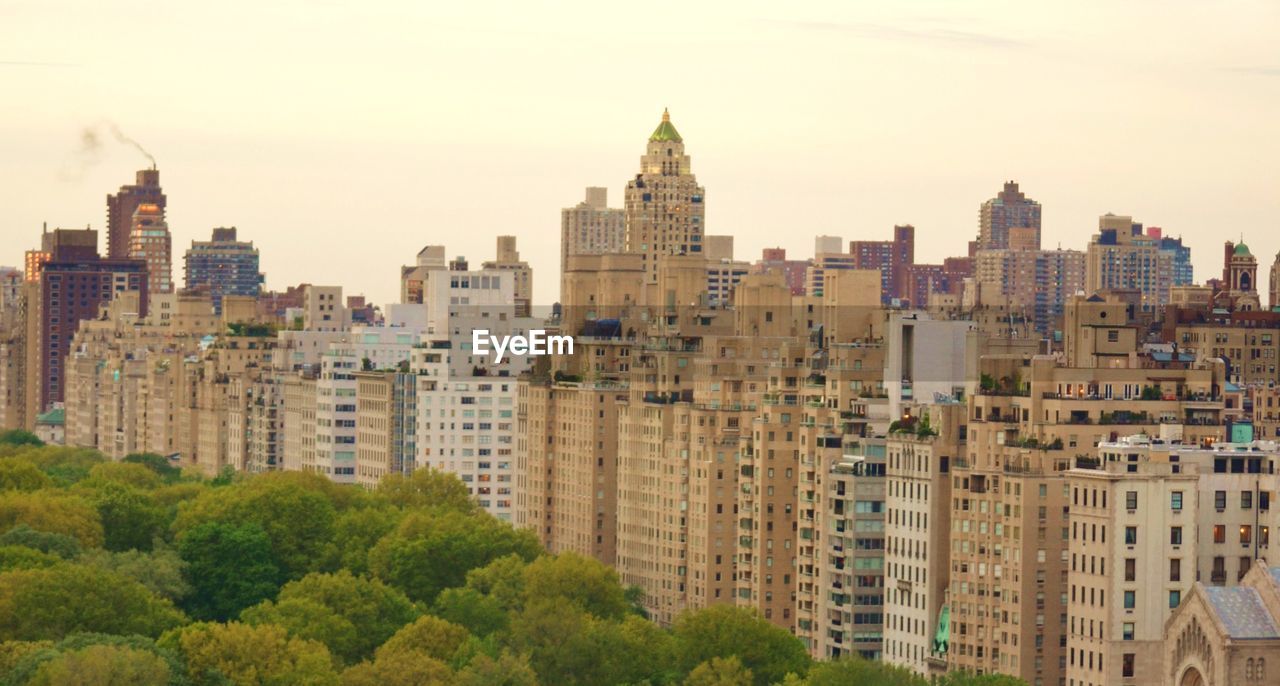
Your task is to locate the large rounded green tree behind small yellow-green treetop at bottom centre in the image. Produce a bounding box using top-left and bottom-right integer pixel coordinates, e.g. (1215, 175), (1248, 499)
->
(675, 605), (810, 686)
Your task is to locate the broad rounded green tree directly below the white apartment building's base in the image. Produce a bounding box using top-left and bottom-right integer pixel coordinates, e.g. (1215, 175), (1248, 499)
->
(369, 511), (541, 603)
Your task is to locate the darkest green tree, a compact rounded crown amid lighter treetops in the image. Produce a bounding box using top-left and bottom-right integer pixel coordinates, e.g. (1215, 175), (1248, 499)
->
(178, 522), (280, 621)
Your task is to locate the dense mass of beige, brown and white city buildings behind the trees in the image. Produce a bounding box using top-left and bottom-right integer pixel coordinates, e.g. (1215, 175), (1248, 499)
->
(0, 111), (1280, 686)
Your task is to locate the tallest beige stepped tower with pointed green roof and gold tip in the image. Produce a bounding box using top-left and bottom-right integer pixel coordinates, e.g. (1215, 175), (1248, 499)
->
(626, 110), (707, 283)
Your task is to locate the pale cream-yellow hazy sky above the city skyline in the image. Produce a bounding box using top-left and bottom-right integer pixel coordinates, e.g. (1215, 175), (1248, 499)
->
(0, 0), (1280, 303)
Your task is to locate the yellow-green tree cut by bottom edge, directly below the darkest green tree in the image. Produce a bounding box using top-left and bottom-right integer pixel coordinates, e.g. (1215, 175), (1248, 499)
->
(160, 622), (338, 686)
